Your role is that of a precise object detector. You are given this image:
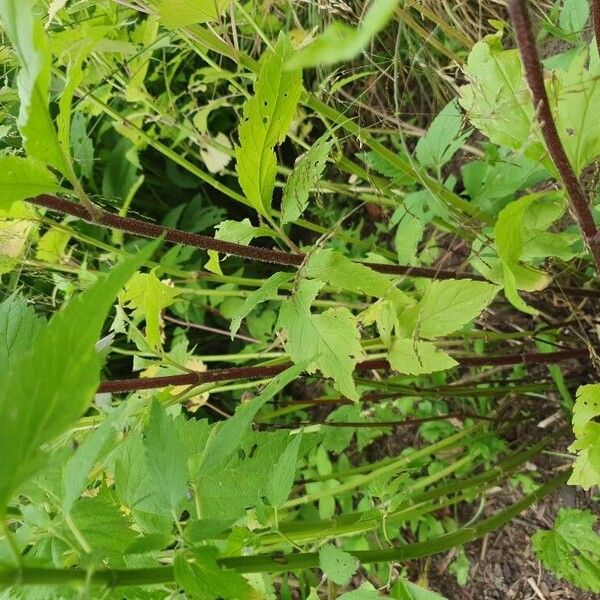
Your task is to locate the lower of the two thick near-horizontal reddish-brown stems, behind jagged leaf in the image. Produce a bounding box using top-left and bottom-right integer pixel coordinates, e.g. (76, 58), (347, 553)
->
(98, 348), (588, 393)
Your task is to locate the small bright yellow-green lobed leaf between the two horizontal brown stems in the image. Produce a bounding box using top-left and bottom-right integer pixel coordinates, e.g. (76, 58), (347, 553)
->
(119, 270), (180, 348)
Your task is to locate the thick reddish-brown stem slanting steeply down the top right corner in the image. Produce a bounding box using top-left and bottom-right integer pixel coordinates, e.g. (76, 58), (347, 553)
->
(507, 0), (600, 274)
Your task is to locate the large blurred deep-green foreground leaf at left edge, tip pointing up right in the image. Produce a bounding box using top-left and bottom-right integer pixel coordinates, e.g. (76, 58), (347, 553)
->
(0, 244), (156, 513)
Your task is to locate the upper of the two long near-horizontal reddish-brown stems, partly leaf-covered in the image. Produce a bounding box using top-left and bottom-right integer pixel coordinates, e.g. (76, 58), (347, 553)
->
(27, 194), (485, 281)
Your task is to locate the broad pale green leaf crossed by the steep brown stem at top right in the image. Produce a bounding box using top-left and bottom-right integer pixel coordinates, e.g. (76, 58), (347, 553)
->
(459, 33), (600, 175)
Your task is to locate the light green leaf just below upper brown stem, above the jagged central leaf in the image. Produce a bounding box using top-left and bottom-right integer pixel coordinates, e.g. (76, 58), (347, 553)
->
(304, 248), (414, 310)
